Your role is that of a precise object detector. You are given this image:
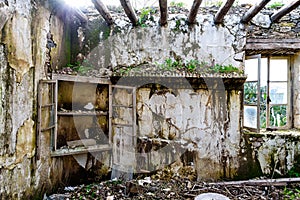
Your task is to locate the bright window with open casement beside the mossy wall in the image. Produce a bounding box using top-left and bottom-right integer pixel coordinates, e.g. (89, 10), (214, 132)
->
(244, 55), (289, 132)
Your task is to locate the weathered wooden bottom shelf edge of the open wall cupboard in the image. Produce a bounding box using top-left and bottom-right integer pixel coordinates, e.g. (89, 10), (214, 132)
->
(51, 144), (112, 157)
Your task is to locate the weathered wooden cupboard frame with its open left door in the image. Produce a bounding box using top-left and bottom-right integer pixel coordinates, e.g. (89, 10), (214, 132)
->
(37, 75), (112, 159)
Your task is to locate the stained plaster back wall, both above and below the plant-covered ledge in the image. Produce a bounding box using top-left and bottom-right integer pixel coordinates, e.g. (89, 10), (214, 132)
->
(83, 8), (246, 180)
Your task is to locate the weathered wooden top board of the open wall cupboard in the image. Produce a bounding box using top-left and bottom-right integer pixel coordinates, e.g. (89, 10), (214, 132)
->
(52, 74), (111, 84)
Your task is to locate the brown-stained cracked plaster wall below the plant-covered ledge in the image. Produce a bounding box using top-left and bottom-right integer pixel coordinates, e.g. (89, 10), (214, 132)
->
(137, 84), (241, 180)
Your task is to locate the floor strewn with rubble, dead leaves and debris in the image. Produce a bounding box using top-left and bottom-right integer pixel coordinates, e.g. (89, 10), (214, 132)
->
(44, 166), (300, 200)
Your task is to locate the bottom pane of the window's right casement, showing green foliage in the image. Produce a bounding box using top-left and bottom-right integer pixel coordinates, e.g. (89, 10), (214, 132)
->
(270, 106), (287, 127)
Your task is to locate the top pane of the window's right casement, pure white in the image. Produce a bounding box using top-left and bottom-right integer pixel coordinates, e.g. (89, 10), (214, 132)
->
(270, 59), (288, 81)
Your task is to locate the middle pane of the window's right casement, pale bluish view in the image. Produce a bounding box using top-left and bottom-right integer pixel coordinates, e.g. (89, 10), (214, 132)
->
(270, 83), (287, 104)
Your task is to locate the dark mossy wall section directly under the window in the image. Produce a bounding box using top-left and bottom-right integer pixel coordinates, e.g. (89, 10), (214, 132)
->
(241, 130), (300, 178)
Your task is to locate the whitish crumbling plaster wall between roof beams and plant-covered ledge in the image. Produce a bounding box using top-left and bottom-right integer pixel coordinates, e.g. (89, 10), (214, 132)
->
(86, 8), (246, 73)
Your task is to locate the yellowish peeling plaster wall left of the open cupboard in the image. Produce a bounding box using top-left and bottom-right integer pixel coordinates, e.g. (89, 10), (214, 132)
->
(0, 0), (72, 199)
